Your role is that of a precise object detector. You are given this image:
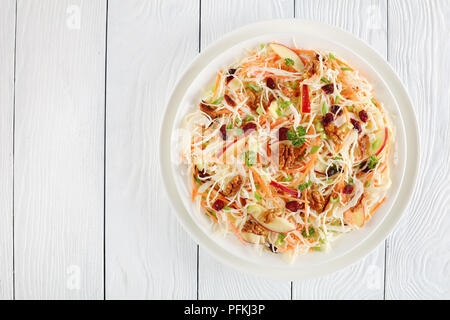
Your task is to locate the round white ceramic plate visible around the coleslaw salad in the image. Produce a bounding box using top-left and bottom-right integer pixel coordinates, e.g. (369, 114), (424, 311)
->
(160, 20), (419, 280)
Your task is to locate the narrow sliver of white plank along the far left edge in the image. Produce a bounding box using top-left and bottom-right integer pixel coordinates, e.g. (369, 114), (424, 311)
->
(0, 0), (16, 300)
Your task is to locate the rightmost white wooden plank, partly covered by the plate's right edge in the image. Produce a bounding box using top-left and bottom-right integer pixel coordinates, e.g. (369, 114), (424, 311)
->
(386, 0), (450, 299)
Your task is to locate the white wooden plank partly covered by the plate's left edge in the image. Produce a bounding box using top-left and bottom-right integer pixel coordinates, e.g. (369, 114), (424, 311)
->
(106, 0), (199, 299)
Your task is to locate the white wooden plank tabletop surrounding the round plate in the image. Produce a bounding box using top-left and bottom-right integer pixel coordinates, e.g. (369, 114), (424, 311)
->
(0, 0), (450, 299)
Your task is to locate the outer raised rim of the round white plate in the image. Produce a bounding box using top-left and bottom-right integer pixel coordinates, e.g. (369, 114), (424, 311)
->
(159, 19), (420, 280)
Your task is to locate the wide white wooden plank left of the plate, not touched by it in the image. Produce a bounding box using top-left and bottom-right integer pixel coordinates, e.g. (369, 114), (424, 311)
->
(14, 0), (106, 299)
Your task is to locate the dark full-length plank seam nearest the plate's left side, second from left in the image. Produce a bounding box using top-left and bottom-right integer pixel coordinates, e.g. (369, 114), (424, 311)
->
(103, 0), (109, 300)
